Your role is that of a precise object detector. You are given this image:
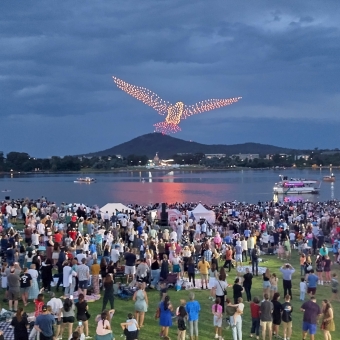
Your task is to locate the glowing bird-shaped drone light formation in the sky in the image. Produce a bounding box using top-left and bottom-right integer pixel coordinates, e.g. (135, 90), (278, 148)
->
(112, 77), (242, 134)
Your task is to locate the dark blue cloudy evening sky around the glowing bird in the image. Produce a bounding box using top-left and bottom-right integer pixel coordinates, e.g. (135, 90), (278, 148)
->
(0, 0), (340, 157)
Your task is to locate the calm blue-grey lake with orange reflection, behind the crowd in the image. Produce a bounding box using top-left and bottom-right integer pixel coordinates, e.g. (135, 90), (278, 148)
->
(0, 169), (340, 206)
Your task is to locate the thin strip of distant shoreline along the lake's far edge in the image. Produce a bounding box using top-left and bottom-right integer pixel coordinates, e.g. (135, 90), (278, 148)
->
(0, 166), (334, 176)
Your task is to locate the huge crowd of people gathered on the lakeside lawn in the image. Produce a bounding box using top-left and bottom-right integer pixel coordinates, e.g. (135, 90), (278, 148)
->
(0, 198), (340, 340)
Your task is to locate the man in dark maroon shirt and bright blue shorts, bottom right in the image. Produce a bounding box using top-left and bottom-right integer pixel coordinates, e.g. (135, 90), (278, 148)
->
(300, 296), (321, 340)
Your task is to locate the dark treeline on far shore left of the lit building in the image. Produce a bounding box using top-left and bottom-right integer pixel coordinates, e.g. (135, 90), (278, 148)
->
(0, 152), (148, 172)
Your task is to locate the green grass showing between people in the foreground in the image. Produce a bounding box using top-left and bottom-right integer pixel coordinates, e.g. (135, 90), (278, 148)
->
(1, 226), (340, 340)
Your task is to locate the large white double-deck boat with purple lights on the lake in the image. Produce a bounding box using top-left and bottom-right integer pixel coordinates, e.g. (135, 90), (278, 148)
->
(273, 175), (321, 195)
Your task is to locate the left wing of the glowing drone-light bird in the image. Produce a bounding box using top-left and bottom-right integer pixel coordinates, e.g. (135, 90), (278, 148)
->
(112, 77), (169, 115)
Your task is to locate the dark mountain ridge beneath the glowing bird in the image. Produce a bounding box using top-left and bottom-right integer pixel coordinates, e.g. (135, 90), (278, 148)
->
(86, 133), (299, 159)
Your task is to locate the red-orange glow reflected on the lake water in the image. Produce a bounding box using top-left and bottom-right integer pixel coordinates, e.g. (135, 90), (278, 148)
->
(109, 182), (233, 204)
